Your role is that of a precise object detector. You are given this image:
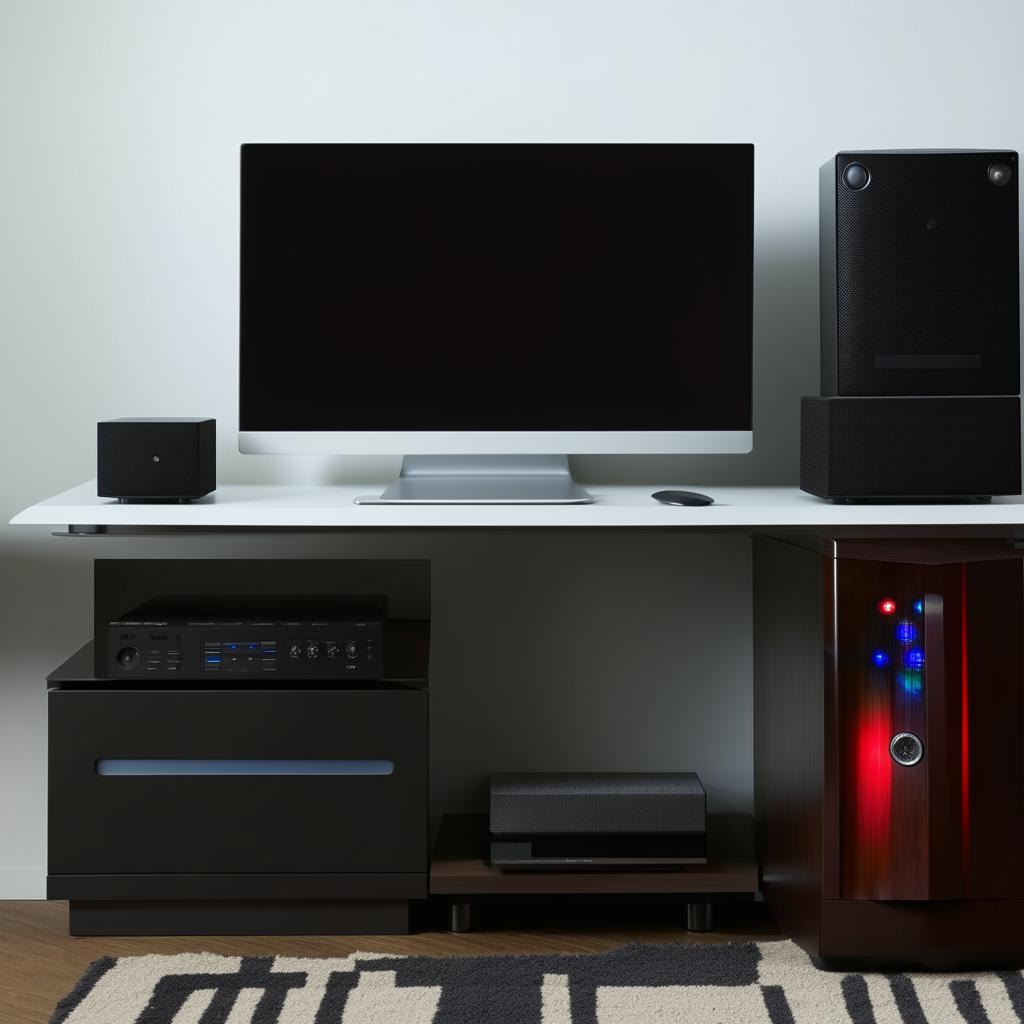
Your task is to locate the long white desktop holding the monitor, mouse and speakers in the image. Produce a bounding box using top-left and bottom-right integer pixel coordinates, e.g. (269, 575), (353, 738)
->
(11, 480), (1024, 534)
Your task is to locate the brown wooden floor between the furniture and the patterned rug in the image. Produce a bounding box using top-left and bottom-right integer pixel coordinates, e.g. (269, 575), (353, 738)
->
(0, 901), (779, 1024)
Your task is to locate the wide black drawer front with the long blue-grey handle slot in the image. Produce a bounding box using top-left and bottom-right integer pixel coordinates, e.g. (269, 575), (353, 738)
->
(49, 689), (428, 876)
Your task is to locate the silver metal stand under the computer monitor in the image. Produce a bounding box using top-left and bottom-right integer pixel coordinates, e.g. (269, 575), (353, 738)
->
(355, 455), (594, 505)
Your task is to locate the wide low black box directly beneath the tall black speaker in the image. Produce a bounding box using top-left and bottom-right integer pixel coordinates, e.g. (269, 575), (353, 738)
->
(800, 395), (1021, 502)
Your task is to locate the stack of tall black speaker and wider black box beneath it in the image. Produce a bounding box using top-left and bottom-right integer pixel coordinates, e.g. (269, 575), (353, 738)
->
(801, 150), (1021, 501)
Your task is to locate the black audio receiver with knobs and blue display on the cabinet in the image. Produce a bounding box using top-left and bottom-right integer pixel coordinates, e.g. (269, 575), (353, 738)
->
(106, 601), (384, 682)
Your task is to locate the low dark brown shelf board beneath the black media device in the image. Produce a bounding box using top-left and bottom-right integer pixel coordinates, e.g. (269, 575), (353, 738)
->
(430, 814), (758, 896)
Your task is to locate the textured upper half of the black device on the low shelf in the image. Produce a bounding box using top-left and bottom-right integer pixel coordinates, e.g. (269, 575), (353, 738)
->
(490, 772), (705, 836)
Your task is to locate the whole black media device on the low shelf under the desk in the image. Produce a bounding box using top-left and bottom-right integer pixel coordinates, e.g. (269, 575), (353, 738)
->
(490, 772), (708, 870)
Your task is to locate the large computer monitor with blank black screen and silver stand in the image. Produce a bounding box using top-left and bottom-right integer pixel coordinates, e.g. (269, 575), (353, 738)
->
(239, 143), (754, 501)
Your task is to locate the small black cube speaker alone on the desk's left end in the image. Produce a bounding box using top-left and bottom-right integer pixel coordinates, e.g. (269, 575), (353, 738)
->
(96, 419), (217, 502)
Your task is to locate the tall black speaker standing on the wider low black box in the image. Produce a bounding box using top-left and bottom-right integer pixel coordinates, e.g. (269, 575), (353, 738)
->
(819, 150), (1020, 396)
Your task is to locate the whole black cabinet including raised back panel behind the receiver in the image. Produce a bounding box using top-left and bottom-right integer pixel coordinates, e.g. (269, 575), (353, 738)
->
(47, 559), (430, 935)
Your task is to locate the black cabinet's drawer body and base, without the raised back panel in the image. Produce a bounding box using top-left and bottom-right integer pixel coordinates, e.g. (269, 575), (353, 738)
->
(47, 684), (429, 935)
